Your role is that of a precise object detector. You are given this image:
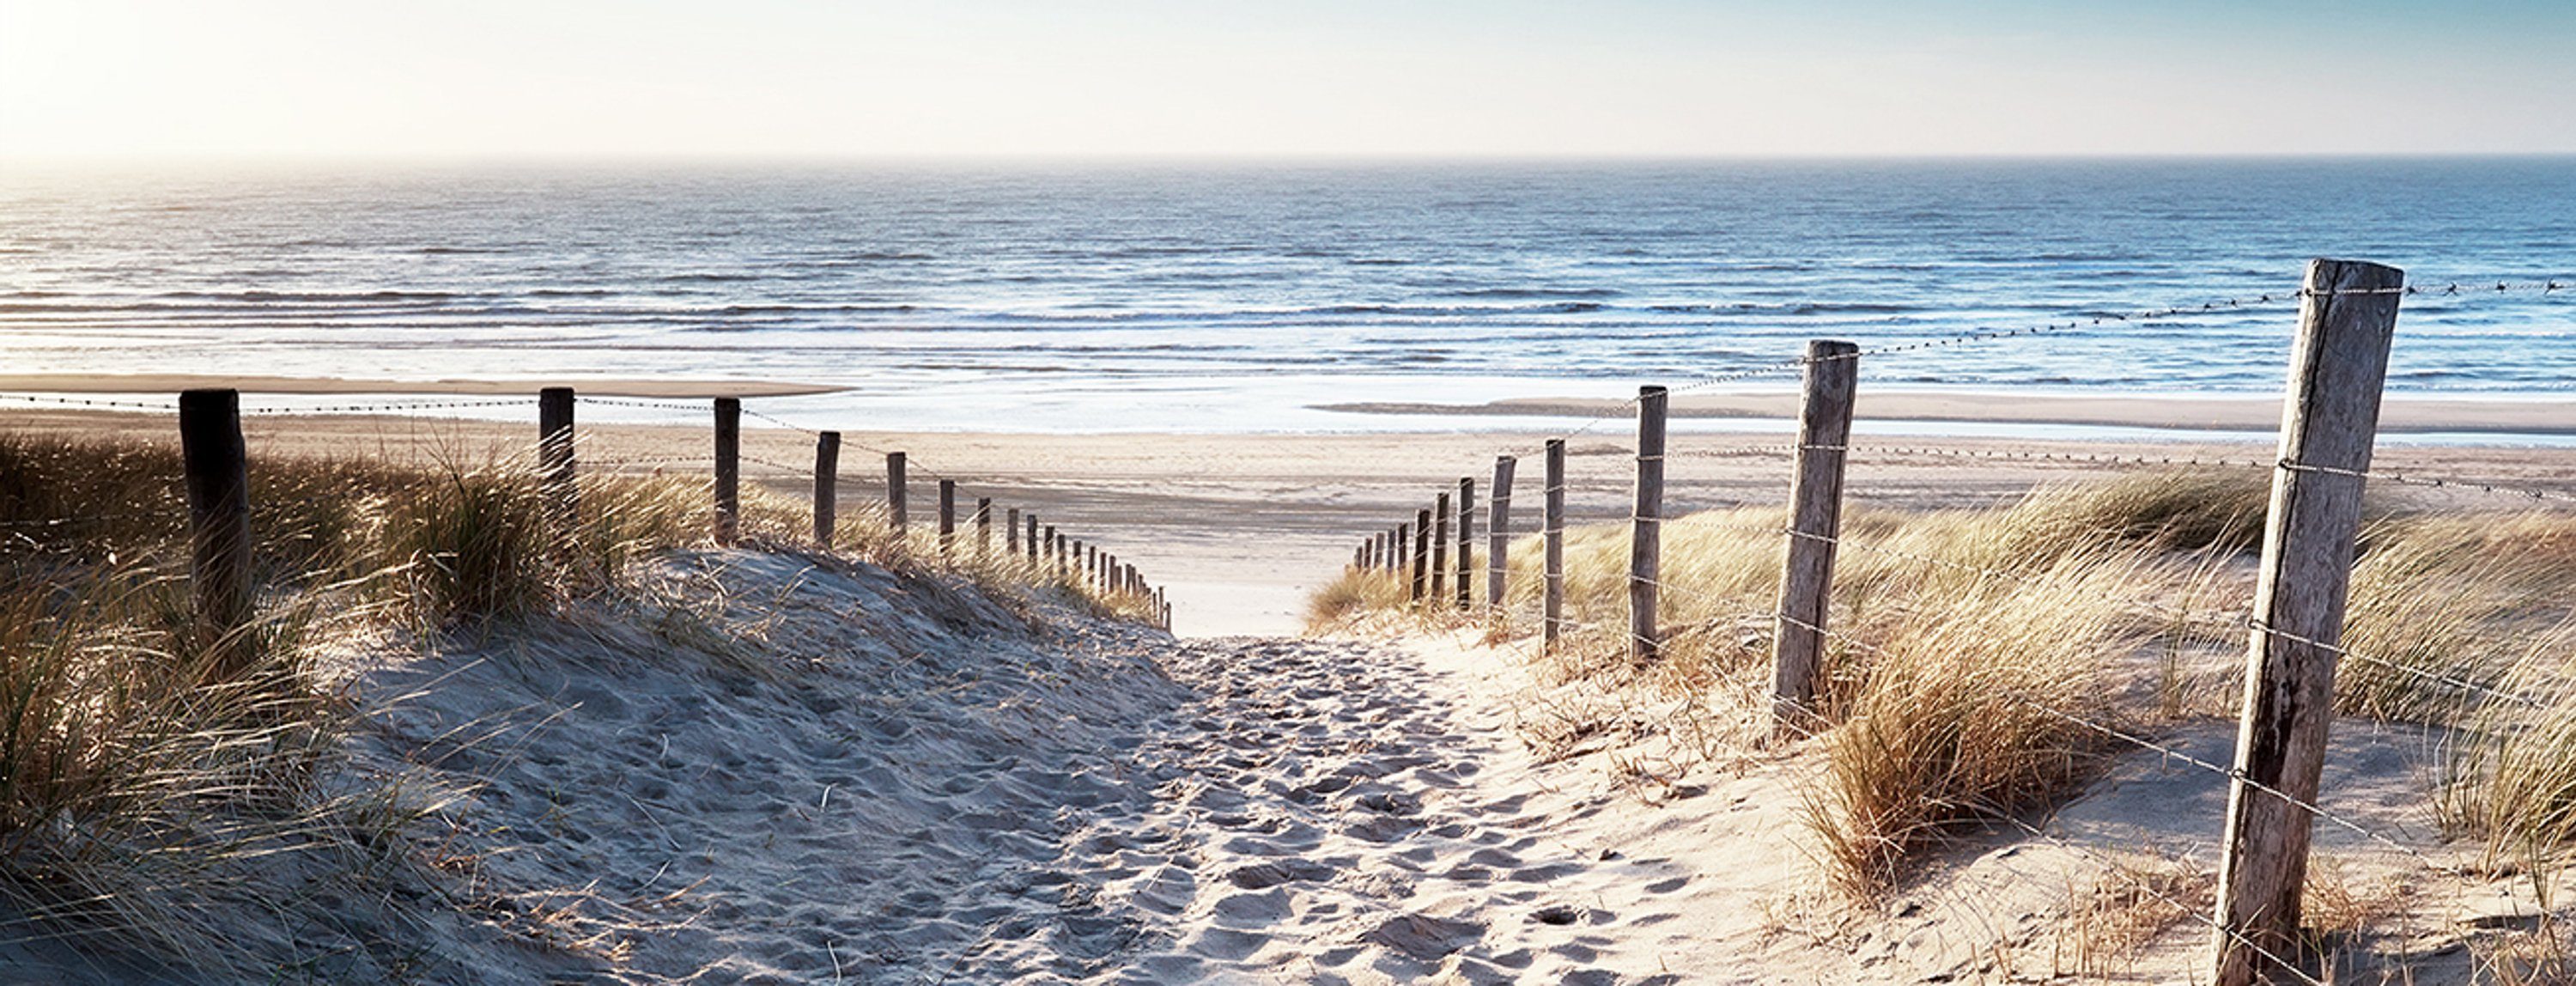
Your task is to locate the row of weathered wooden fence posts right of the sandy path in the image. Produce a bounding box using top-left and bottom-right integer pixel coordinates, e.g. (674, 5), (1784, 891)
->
(1352, 260), (2406, 986)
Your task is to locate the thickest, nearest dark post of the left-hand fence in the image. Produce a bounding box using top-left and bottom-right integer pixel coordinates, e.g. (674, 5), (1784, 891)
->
(178, 389), (252, 679)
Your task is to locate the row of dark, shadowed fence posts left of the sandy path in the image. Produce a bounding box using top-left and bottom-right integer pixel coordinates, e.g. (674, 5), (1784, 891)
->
(178, 386), (1172, 648)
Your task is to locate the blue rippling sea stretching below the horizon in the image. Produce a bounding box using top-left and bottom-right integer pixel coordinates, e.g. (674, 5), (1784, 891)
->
(0, 157), (2576, 433)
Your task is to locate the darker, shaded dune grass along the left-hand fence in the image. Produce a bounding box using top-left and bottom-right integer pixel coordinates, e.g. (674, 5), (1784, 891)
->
(0, 435), (1146, 976)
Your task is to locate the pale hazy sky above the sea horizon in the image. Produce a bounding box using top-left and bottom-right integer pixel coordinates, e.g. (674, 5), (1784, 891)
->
(0, 0), (2576, 157)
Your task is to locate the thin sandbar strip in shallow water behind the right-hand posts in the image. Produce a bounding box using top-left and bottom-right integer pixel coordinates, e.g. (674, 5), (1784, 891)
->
(1309, 392), (2576, 435)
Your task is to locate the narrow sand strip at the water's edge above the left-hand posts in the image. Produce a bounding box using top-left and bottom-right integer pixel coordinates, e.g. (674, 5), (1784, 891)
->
(0, 374), (848, 399)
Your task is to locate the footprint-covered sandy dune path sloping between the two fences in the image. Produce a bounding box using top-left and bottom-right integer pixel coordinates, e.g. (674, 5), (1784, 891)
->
(0, 551), (2532, 983)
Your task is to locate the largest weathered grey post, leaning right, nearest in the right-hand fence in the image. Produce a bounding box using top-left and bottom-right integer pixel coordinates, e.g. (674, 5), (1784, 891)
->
(2215, 260), (2406, 986)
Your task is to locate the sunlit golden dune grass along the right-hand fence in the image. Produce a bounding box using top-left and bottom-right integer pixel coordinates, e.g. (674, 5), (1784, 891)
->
(1311, 469), (2576, 898)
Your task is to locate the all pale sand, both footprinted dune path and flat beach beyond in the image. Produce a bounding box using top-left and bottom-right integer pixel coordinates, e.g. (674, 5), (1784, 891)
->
(8, 412), (2576, 983)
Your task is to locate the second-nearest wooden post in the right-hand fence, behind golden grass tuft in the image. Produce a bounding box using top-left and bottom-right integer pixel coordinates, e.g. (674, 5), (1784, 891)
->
(1772, 340), (1860, 736)
